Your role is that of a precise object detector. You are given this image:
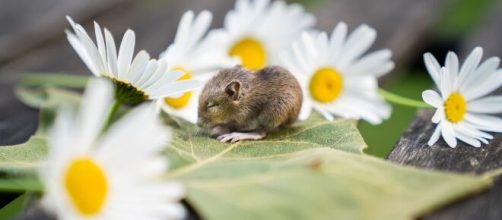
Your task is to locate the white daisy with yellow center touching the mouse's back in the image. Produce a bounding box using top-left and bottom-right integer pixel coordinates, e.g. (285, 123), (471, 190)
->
(282, 23), (394, 124)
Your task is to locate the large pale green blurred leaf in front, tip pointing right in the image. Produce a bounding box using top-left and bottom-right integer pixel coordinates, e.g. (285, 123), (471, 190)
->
(178, 146), (491, 220)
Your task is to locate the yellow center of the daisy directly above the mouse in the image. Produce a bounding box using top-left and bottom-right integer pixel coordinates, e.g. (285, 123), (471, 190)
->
(228, 37), (267, 70)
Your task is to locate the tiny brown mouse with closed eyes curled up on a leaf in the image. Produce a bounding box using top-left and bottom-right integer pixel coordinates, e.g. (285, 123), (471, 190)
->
(197, 66), (303, 143)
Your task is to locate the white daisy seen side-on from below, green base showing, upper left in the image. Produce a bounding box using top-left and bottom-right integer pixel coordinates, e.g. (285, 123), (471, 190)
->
(66, 17), (200, 105)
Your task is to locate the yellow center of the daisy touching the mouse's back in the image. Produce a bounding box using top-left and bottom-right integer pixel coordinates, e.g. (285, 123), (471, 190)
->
(309, 67), (343, 103)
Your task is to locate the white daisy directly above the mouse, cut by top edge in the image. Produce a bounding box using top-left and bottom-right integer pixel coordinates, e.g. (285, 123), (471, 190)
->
(205, 0), (315, 70)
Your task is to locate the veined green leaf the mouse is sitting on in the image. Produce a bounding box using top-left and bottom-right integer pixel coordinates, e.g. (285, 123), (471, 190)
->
(166, 114), (366, 169)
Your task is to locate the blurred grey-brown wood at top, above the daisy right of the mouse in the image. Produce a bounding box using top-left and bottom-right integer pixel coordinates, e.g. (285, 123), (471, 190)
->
(315, 0), (455, 68)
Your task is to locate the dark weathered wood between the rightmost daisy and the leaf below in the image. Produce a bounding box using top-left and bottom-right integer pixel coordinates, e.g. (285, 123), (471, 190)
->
(387, 110), (502, 173)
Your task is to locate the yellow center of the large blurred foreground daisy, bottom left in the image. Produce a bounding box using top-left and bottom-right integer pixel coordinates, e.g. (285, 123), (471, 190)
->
(64, 157), (108, 216)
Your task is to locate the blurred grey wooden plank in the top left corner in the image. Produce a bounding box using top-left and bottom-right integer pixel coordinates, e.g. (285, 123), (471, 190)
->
(0, 0), (128, 64)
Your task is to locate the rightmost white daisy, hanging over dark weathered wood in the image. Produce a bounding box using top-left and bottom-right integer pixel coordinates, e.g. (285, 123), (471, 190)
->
(422, 47), (502, 147)
